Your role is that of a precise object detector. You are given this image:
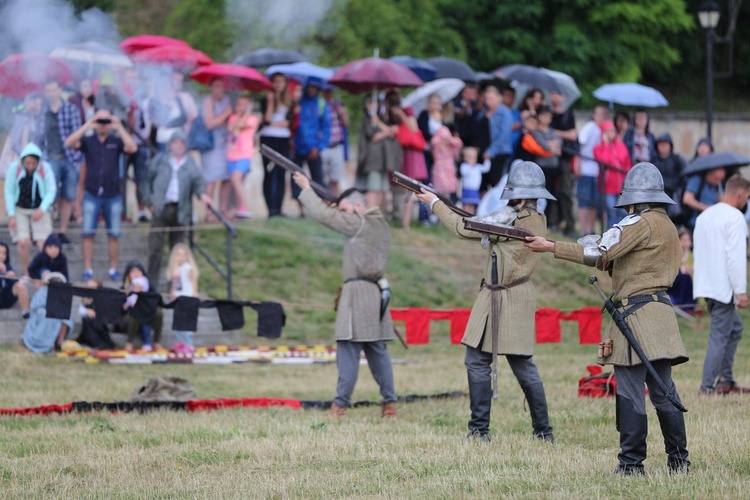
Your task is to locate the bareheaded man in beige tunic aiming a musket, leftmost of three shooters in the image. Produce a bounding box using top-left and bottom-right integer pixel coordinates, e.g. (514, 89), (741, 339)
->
(293, 173), (397, 418)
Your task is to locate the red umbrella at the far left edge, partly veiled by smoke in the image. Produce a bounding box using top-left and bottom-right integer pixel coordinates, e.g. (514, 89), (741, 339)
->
(0, 52), (73, 99)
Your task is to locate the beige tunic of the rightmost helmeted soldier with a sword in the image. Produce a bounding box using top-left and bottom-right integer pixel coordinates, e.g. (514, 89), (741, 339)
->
(555, 209), (688, 366)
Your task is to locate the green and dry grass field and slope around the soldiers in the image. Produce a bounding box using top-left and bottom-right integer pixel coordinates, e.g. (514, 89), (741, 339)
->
(0, 220), (750, 498)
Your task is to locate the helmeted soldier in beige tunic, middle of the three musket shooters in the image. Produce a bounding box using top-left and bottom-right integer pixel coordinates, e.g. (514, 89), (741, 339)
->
(417, 161), (555, 442)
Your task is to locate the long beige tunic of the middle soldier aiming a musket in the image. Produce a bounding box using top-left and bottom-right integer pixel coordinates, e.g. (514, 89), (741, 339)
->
(433, 202), (547, 356)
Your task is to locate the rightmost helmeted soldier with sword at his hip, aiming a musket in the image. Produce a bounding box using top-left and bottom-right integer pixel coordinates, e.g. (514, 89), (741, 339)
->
(526, 162), (690, 475)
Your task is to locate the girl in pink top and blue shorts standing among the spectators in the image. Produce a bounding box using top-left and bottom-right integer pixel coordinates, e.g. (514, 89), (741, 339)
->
(227, 95), (260, 219)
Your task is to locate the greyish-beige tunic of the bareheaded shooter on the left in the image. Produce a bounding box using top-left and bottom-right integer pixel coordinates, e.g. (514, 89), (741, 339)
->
(299, 188), (394, 342)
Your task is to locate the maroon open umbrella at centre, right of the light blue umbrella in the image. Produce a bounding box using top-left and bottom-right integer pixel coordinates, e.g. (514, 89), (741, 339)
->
(328, 57), (423, 92)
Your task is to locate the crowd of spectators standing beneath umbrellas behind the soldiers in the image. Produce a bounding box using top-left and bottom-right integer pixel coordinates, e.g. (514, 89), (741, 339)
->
(0, 65), (748, 356)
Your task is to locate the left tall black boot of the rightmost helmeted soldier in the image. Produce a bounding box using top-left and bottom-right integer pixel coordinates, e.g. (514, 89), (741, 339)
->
(615, 396), (648, 476)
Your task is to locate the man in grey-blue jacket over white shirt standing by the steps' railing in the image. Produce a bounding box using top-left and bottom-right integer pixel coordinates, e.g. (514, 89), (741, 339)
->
(144, 131), (212, 290)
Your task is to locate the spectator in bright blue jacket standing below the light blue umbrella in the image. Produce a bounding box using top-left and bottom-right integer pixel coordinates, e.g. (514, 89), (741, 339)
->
(292, 78), (331, 210)
